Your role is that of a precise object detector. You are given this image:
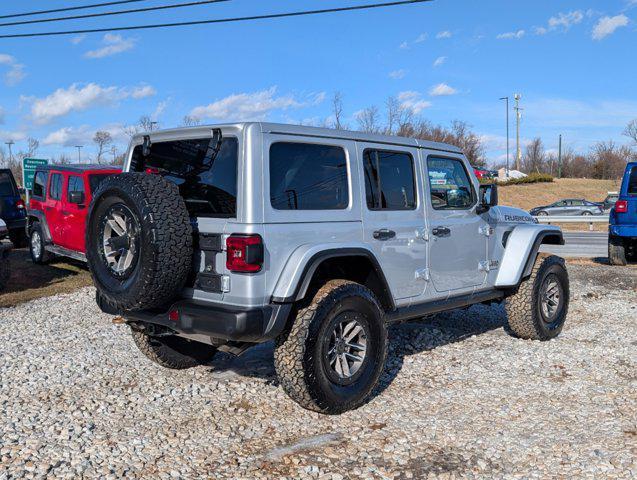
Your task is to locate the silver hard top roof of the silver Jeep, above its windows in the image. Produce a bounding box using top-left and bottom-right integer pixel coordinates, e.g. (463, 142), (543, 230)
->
(133, 122), (462, 153)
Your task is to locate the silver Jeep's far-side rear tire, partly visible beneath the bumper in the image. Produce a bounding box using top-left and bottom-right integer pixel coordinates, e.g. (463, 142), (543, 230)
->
(131, 329), (217, 370)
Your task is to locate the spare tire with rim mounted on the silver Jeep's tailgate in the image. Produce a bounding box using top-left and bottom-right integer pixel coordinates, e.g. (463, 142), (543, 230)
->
(86, 173), (193, 311)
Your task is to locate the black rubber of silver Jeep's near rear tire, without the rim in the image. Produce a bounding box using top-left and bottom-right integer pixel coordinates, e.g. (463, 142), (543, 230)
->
(274, 280), (387, 415)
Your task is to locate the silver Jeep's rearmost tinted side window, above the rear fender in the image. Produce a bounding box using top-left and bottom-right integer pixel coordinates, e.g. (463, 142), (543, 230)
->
(270, 142), (349, 210)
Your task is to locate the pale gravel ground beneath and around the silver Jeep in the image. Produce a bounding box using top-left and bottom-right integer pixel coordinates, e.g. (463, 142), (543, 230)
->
(0, 265), (637, 479)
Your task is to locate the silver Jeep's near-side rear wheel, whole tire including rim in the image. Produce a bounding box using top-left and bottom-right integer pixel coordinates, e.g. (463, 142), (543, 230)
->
(274, 280), (387, 414)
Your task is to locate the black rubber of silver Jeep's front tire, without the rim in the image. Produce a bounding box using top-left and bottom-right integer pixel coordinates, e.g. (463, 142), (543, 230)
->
(505, 255), (570, 341)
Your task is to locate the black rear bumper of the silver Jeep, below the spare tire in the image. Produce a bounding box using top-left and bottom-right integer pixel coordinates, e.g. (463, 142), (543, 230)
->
(102, 300), (292, 343)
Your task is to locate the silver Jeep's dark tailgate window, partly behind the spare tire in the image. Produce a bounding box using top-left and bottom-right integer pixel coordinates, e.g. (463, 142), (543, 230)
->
(131, 137), (239, 218)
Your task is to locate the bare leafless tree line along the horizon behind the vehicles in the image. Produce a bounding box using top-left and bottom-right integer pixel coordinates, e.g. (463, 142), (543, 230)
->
(0, 92), (637, 182)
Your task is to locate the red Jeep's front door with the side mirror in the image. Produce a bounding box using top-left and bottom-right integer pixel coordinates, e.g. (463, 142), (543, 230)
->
(61, 174), (86, 253)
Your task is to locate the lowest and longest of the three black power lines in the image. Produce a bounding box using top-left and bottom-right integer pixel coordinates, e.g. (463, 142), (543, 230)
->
(0, 0), (433, 39)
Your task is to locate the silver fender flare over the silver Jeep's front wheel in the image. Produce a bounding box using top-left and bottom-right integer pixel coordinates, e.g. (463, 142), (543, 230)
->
(495, 225), (564, 288)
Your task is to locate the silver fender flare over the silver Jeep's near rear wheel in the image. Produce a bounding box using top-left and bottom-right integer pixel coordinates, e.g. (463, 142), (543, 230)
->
(272, 243), (393, 304)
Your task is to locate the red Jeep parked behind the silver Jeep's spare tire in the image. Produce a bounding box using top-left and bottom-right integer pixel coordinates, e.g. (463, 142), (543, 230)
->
(26, 165), (122, 263)
